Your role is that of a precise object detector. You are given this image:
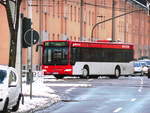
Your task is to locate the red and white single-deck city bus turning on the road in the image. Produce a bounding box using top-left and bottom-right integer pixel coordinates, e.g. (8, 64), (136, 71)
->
(42, 40), (134, 78)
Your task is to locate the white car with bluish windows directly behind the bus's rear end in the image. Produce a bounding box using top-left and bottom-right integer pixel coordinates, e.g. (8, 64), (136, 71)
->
(134, 61), (148, 75)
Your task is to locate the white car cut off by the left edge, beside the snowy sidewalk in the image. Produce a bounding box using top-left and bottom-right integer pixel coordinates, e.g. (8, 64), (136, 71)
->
(0, 65), (22, 113)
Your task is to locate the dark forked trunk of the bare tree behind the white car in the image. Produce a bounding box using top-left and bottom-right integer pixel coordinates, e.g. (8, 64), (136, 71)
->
(0, 0), (22, 67)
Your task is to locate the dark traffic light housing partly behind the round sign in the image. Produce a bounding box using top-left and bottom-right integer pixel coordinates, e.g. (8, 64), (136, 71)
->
(22, 17), (32, 48)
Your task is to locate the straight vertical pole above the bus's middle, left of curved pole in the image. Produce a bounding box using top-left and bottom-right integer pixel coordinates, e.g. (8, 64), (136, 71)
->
(80, 0), (84, 41)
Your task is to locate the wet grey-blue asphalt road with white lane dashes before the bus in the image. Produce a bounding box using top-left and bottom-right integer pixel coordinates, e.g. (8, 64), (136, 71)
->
(36, 77), (150, 113)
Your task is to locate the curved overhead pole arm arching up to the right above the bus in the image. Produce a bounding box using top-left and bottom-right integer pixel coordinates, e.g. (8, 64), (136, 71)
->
(91, 9), (143, 41)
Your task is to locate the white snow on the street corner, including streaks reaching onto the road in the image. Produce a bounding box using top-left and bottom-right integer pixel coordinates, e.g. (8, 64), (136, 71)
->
(15, 74), (91, 113)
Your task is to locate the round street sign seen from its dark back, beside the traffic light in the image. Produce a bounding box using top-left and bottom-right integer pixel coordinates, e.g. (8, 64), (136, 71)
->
(24, 29), (39, 47)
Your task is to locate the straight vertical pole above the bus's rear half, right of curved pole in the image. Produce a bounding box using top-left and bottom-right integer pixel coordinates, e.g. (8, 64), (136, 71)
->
(112, 0), (115, 41)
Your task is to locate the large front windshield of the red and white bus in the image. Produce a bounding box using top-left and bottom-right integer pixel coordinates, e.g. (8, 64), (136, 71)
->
(43, 47), (68, 65)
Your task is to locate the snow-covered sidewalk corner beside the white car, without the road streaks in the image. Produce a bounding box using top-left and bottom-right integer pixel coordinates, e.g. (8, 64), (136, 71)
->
(15, 76), (60, 113)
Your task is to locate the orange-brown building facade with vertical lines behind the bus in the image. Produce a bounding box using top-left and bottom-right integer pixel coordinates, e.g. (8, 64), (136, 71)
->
(0, 0), (150, 68)
